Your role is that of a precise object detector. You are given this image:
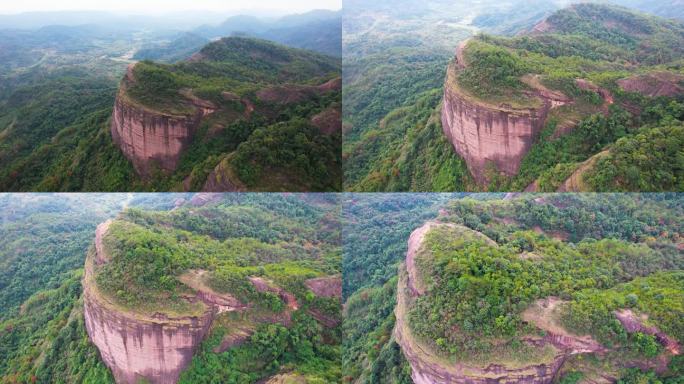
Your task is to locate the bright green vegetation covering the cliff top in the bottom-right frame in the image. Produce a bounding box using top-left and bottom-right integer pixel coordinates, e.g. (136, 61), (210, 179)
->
(408, 195), (684, 373)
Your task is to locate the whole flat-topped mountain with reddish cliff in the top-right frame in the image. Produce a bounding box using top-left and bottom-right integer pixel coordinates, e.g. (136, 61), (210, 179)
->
(441, 4), (684, 191)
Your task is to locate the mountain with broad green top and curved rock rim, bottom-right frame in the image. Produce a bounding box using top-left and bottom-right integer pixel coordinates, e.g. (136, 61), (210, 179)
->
(394, 195), (684, 384)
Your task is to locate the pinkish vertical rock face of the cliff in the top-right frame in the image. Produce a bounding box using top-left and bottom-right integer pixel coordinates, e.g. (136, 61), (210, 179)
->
(441, 56), (569, 184)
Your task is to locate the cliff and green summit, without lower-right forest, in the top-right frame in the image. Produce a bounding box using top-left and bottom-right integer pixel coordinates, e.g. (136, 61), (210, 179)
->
(441, 4), (684, 190)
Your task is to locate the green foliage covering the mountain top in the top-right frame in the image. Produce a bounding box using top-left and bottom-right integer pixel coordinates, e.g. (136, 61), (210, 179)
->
(460, 4), (684, 98)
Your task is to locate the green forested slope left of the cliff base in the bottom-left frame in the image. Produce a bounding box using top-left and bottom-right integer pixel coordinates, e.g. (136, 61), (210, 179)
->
(0, 271), (114, 384)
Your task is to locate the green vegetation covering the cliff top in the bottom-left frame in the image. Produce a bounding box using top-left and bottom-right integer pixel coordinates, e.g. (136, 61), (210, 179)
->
(97, 195), (340, 314)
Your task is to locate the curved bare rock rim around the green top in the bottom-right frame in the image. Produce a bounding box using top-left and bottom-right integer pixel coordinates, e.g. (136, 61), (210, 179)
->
(394, 222), (601, 384)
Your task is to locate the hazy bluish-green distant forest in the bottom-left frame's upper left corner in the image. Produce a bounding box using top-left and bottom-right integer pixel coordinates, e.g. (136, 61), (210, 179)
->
(0, 195), (130, 320)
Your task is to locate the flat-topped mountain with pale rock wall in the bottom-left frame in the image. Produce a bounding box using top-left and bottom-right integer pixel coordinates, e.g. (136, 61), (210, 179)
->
(83, 195), (341, 383)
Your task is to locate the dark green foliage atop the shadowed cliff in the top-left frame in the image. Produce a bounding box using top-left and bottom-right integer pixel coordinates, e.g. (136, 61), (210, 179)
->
(127, 37), (340, 114)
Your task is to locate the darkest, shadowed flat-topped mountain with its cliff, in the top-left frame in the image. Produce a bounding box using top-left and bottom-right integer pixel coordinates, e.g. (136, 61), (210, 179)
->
(111, 37), (340, 190)
